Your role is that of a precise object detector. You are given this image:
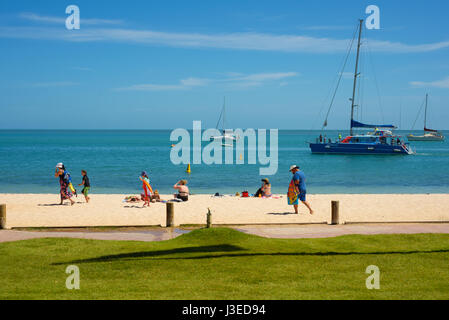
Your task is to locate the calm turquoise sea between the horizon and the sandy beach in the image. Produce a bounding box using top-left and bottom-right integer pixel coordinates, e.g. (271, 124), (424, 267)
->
(0, 130), (449, 194)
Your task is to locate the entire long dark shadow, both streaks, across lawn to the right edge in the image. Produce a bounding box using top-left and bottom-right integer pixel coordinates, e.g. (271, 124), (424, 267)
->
(53, 244), (449, 265)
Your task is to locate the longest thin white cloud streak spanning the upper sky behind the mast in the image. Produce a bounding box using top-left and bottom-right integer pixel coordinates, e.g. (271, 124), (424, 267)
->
(0, 27), (449, 53)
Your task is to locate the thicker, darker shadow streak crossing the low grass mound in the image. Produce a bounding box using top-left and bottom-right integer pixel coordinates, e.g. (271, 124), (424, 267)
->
(53, 244), (245, 265)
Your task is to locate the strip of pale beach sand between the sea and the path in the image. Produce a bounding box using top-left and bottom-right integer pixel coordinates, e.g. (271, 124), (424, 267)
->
(0, 194), (449, 228)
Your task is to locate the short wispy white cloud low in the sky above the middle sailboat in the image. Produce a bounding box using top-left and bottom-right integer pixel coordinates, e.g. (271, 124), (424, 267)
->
(116, 72), (298, 91)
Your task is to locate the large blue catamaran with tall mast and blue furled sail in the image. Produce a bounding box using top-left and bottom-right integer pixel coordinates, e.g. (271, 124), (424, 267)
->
(309, 20), (413, 155)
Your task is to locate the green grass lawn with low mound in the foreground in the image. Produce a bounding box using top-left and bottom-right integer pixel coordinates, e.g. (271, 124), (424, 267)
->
(0, 228), (449, 299)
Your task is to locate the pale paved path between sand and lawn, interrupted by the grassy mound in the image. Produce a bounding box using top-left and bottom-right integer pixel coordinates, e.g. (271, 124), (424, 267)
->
(0, 223), (449, 242)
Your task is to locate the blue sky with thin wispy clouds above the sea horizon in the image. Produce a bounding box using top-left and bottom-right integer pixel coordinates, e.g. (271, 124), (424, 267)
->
(0, 0), (449, 129)
